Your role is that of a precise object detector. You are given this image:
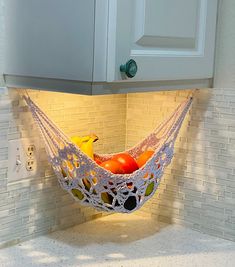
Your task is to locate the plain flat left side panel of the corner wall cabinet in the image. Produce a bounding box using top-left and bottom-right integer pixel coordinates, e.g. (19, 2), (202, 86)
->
(5, 0), (95, 81)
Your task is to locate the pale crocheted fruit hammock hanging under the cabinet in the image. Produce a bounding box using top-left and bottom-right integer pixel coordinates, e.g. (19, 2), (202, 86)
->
(24, 96), (192, 213)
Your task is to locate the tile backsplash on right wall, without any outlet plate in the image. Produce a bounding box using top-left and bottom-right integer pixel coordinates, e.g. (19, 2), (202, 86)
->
(126, 88), (235, 241)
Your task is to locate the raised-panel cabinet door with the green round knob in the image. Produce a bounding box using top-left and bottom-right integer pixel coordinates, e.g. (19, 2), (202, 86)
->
(107, 0), (217, 81)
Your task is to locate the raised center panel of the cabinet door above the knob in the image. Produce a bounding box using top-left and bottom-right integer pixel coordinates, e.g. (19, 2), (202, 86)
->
(135, 0), (199, 48)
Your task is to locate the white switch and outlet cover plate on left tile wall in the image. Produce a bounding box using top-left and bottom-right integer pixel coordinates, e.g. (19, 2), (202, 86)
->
(8, 138), (39, 182)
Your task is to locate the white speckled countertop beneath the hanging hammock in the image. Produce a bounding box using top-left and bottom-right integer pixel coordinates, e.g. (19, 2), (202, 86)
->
(0, 214), (235, 267)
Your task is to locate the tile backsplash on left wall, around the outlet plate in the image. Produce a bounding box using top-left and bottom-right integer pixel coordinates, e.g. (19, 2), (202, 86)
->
(0, 89), (126, 247)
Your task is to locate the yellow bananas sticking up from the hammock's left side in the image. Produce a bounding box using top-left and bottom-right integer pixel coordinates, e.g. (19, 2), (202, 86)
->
(71, 134), (99, 159)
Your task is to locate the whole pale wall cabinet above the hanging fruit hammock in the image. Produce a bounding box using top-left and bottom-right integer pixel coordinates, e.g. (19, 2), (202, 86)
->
(5, 0), (217, 94)
